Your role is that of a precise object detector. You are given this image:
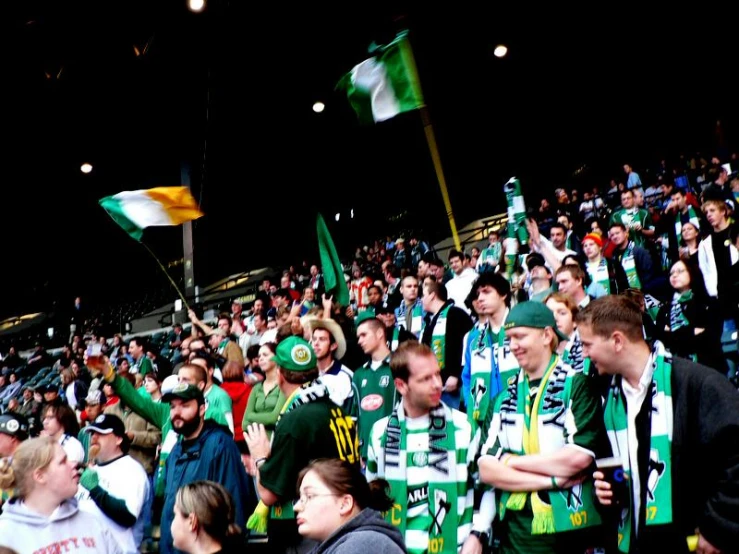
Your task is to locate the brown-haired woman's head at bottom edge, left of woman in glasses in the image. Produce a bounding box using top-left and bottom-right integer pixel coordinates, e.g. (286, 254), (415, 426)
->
(171, 481), (244, 554)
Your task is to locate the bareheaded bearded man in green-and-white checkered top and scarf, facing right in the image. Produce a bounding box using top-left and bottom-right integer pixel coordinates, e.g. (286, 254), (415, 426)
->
(367, 341), (492, 554)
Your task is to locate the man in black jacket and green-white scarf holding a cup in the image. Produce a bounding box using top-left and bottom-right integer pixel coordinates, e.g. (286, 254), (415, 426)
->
(577, 295), (739, 554)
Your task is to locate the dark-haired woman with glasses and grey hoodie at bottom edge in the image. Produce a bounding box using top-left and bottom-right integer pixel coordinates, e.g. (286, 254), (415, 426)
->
(295, 459), (406, 554)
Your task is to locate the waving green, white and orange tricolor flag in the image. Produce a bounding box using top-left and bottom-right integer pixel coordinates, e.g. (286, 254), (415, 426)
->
(99, 187), (203, 241)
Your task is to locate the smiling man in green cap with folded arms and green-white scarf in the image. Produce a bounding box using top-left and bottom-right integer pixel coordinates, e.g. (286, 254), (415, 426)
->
(478, 301), (610, 554)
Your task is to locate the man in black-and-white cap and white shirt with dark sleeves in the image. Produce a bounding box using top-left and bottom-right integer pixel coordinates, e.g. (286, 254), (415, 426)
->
(77, 414), (151, 553)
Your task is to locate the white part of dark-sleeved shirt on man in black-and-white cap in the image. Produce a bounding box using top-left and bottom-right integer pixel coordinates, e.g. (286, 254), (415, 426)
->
(76, 456), (150, 554)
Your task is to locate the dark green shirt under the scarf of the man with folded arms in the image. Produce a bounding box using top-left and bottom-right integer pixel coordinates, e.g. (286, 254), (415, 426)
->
(485, 373), (610, 554)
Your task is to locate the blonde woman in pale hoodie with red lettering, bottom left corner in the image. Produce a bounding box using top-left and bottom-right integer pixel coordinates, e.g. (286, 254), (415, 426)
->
(0, 437), (122, 554)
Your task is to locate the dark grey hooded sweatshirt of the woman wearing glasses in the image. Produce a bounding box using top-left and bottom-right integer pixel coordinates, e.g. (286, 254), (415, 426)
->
(310, 508), (406, 554)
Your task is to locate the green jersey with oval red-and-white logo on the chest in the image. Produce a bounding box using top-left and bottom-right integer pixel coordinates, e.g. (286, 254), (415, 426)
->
(354, 357), (398, 460)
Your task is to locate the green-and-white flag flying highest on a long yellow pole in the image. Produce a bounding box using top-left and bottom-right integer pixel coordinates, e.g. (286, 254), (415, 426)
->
(339, 31), (424, 123)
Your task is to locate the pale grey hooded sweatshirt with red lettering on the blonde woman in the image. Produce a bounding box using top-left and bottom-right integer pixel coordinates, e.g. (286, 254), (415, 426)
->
(0, 498), (122, 554)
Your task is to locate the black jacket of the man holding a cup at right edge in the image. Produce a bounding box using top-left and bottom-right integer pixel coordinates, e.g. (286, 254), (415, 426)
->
(604, 358), (739, 554)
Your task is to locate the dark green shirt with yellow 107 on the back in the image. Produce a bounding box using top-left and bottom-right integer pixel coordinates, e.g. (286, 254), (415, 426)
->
(259, 397), (359, 552)
